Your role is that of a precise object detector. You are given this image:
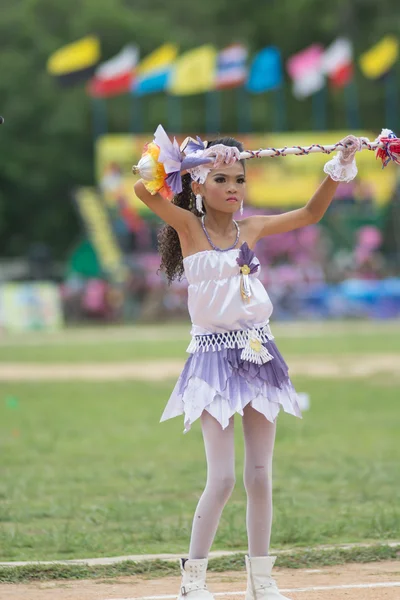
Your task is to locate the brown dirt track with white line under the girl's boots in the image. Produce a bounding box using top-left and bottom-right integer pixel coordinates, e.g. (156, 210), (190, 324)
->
(0, 561), (400, 600)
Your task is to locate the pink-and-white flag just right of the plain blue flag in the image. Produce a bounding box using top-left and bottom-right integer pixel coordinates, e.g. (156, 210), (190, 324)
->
(286, 44), (325, 99)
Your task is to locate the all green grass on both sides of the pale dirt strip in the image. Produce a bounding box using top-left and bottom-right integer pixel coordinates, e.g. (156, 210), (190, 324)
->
(0, 323), (400, 561)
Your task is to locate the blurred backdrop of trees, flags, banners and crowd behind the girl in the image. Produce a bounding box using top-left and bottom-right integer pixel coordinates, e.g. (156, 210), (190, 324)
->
(0, 0), (400, 331)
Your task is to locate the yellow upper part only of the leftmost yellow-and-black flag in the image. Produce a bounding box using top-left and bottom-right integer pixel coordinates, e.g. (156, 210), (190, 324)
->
(47, 36), (100, 77)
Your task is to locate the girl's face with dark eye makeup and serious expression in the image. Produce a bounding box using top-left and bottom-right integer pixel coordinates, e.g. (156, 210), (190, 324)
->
(195, 161), (246, 213)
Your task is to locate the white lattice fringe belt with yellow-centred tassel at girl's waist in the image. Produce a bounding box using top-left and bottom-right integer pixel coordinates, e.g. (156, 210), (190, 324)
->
(186, 324), (274, 365)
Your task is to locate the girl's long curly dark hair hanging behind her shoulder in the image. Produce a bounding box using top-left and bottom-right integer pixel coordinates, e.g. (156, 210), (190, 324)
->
(157, 137), (245, 285)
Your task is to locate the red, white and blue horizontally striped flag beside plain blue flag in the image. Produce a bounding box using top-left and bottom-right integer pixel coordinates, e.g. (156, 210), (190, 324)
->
(215, 44), (248, 90)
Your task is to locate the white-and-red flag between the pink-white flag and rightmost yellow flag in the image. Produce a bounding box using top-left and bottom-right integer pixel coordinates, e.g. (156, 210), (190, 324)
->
(322, 38), (353, 88)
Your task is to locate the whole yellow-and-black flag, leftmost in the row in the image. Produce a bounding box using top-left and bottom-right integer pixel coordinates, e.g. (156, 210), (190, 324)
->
(47, 36), (100, 86)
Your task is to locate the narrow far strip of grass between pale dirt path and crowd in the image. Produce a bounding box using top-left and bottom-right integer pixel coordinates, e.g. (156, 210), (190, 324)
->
(0, 321), (400, 364)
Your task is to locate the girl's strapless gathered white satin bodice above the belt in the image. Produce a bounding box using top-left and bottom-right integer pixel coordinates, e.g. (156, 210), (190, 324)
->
(183, 248), (273, 335)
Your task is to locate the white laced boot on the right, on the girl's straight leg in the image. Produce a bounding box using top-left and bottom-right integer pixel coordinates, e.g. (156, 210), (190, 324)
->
(245, 554), (289, 600)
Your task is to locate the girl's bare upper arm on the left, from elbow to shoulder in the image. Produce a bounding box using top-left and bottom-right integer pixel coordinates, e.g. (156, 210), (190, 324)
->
(134, 179), (197, 233)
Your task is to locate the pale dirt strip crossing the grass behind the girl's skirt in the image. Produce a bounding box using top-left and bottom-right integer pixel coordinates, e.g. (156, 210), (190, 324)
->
(0, 354), (400, 381)
